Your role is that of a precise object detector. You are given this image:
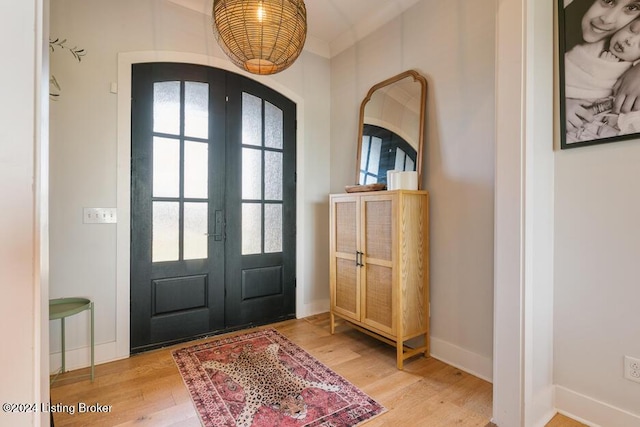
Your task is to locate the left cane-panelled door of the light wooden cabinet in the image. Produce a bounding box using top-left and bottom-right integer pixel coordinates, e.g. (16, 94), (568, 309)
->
(330, 197), (360, 321)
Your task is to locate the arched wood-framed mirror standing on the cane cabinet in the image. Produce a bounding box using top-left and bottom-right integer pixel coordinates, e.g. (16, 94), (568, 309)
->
(356, 70), (427, 189)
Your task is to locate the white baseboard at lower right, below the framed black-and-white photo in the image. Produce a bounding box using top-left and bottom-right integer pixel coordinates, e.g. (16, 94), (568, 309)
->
(556, 385), (640, 427)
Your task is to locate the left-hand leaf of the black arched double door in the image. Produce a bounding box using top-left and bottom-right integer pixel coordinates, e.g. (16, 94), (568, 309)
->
(131, 63), (226, 352)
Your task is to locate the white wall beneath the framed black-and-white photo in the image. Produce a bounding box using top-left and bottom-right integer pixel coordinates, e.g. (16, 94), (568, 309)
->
(554, 140), (640, 426)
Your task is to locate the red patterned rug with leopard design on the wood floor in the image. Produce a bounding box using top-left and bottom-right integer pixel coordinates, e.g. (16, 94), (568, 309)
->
(172, 329), (385, 427)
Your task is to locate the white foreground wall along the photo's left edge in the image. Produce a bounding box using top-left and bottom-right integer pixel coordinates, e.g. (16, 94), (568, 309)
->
(0, 0), (49, 426)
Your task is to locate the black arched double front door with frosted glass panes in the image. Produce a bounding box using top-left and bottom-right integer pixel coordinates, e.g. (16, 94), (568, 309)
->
(131, 63), (296, 352)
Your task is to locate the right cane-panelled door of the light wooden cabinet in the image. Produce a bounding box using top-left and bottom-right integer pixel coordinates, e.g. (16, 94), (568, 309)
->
(360, 195), (397, 335)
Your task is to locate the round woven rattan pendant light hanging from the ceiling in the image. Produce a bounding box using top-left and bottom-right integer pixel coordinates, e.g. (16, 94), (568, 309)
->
(213, 0), (307, 74)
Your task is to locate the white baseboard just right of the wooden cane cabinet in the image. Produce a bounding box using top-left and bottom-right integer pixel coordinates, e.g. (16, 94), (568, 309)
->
(430, 337), (493, 383)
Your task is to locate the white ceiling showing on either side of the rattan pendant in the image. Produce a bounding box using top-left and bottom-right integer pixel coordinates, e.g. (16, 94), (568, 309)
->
(168, 0), (419, 58)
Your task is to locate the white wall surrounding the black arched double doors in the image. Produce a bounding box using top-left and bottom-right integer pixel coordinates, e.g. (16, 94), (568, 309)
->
(51, 0), (330, 369)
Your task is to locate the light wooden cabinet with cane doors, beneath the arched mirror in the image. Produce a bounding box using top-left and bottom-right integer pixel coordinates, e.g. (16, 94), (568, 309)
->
(330, 190), (429, 369)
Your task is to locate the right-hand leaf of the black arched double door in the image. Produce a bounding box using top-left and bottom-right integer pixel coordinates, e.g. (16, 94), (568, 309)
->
(226, 75), (296, 327)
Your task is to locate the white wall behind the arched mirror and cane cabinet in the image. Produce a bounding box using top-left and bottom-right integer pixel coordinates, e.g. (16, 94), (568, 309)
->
(331, 0), (496, 379)
